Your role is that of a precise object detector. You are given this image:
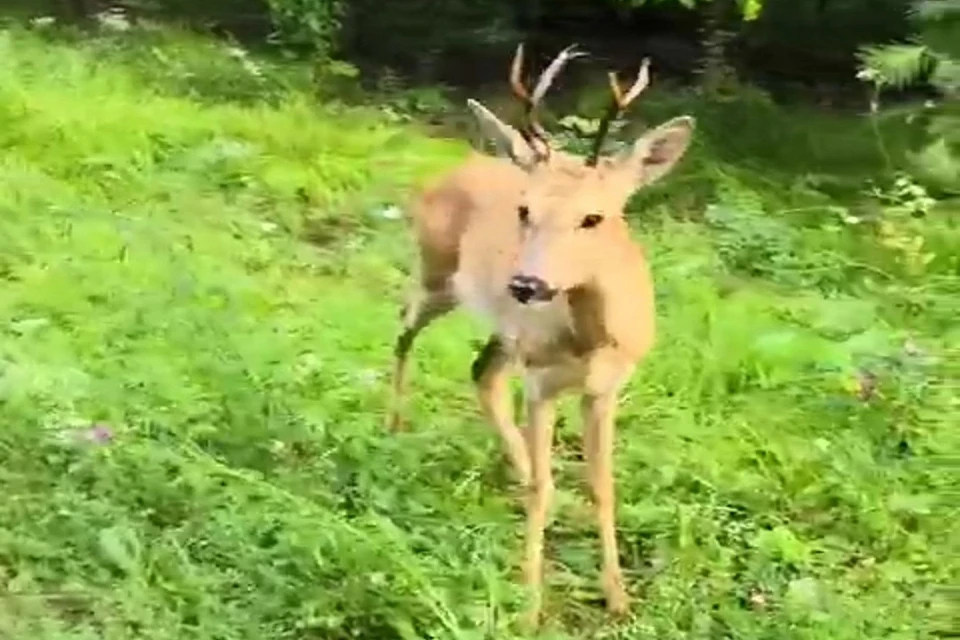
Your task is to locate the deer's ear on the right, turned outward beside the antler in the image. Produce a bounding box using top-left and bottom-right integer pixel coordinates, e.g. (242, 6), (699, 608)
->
(611, 116), (696, 189)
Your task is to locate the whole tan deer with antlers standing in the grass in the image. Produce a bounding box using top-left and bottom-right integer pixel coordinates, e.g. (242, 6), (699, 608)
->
(386, 43), (695, 628)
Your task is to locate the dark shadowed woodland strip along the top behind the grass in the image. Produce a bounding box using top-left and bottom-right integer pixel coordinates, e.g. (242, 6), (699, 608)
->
(50, 0), (910, 89)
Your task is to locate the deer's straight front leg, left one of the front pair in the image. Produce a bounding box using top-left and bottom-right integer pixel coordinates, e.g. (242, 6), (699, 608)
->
(524, 377), (556, 628)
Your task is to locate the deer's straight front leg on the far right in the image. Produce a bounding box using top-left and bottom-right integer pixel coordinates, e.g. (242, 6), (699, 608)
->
(581, 390), (629, 614)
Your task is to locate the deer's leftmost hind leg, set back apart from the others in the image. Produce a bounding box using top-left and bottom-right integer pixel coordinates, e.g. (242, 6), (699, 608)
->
(387, 285), (457, 431)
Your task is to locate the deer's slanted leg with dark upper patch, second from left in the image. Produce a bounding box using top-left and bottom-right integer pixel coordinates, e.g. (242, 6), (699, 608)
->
(470, 335), (531, 487)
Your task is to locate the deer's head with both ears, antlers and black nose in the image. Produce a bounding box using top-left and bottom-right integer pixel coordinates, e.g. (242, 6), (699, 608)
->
(467, 44), (694, 304)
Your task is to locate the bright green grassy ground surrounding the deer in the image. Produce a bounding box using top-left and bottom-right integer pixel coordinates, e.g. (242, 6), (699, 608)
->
(0, 22), (960, 640)
